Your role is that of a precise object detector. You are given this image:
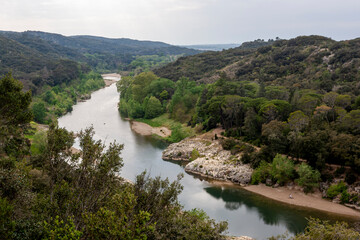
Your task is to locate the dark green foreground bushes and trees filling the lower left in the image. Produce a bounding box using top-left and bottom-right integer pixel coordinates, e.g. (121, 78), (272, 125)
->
(0, 75), (227, 239)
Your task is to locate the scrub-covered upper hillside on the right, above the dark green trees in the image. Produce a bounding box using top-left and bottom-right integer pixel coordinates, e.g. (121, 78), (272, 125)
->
(155, 36), (360, 92)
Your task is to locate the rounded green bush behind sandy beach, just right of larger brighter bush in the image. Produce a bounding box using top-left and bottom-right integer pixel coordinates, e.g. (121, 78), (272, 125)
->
(296, 163), (321, 193)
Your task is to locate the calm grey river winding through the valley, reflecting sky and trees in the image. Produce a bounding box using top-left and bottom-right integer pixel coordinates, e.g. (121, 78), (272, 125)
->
(59, 84), (354, 239)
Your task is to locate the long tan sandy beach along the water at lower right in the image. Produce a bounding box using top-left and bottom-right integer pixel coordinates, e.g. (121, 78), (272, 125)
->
(244, 184), (360, 219)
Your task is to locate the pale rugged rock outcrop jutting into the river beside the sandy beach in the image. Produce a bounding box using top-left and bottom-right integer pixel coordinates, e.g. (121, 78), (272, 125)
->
(163, 138), (253, 185)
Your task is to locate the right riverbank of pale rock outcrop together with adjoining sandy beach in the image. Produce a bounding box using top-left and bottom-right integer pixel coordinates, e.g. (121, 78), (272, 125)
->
(162, 129), (360, 219)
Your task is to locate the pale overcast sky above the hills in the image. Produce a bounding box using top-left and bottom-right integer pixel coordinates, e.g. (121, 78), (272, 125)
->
(0, 0), (360, 44)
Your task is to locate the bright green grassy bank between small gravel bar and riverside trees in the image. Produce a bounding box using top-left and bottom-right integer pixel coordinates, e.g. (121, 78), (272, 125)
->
(136, 113), (195, 142)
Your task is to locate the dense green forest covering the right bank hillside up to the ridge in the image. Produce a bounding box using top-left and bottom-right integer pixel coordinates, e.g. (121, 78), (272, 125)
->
(119, 36), (360, 204)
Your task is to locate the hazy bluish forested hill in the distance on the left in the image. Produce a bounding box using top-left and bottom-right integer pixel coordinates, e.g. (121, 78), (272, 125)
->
(0, 31), (200, 91)
